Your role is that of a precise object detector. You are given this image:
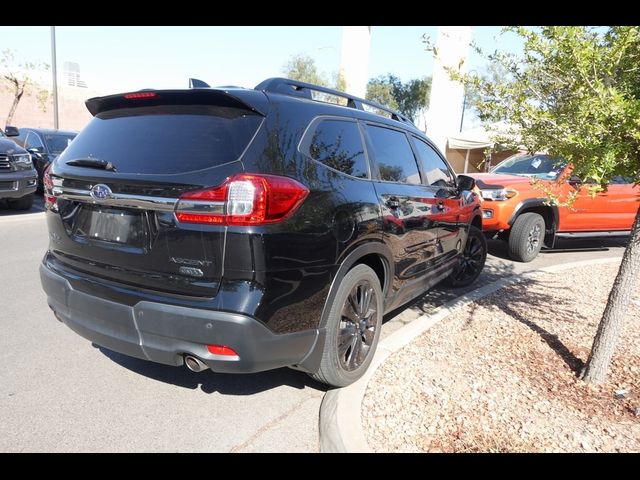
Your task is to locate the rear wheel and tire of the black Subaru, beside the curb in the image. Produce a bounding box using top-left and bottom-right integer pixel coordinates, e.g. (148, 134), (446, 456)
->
(311, 265), (383, 387)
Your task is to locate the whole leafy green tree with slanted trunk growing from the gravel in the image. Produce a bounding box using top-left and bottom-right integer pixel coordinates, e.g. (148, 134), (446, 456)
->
(440, 26), (640, 383)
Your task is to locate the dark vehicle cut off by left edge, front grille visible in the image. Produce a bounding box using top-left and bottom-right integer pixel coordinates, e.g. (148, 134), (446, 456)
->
(0, 127), (38, 210)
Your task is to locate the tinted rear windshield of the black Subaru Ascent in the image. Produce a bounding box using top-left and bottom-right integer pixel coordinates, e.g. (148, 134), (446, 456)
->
(60, 105), (262, 174)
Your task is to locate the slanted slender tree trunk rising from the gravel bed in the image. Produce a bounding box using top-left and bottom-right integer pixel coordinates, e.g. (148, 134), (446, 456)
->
(582, 208), (640, 383)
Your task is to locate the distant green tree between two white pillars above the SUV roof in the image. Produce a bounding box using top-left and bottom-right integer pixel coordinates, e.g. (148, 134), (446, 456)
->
(366, 73), (431, 120)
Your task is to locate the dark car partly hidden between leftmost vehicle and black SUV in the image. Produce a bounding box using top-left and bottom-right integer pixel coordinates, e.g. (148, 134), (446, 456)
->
(14, 128), (78, 188)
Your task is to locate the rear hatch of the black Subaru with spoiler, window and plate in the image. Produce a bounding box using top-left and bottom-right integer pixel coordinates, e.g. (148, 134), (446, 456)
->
(46, 89), (264, 297)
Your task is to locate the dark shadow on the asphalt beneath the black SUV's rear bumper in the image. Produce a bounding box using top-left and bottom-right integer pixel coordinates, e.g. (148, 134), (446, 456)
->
(93, 344), (329, 395)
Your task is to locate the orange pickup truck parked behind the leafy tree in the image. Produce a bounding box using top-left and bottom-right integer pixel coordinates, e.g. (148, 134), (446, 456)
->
(471, 154), (640, 262)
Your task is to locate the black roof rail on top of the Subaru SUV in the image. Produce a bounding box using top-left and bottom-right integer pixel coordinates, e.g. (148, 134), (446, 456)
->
(255, 77), (415, 126)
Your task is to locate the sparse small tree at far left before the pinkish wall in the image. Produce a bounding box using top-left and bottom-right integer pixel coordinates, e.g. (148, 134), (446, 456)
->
(0, 49), (49, 125)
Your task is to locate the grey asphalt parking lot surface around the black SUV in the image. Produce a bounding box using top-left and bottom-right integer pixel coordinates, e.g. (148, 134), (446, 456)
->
(0, 199), (626, 452)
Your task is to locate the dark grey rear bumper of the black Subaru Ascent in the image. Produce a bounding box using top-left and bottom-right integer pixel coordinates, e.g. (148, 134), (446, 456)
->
(40, 264), (318, 373)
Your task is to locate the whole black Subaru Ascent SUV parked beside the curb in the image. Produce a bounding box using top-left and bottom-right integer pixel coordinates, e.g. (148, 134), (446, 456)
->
(40, 78), (486, 386)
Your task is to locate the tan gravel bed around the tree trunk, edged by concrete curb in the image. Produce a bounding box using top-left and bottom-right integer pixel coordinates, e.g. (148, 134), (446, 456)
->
(362, 264), (640, 452)
